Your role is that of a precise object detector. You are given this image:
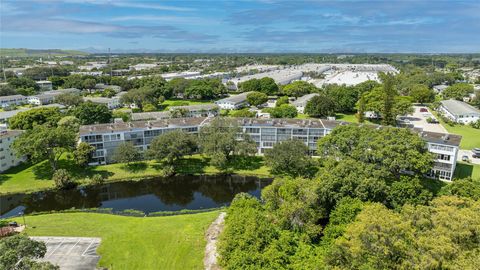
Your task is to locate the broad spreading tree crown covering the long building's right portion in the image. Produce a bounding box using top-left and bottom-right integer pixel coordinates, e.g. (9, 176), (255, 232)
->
(317, 125), (433, 178)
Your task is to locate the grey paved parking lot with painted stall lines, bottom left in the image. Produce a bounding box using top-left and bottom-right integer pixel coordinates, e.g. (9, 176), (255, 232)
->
(31, 237), (101, 270)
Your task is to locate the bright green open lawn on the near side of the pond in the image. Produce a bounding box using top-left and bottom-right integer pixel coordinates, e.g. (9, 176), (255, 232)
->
(11, 211), (218, 269)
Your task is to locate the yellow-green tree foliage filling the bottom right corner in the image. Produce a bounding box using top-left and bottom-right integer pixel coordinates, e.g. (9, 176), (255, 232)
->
(325, 197), (480, 269)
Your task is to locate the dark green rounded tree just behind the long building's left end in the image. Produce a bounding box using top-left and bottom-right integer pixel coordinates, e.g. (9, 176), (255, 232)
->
(72, 101), (112, 125)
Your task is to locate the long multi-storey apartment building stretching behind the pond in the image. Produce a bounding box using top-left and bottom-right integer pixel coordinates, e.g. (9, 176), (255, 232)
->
(80, 117), (461, 181)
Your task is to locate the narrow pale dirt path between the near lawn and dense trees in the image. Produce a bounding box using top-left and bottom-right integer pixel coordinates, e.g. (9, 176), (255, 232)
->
(203, 212), (227, 270)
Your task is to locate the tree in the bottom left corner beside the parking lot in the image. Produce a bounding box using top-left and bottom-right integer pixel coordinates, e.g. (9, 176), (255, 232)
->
(0, 234), (60, 270)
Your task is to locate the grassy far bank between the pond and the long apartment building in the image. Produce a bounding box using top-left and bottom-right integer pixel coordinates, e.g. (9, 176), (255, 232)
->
(0, 155), (271, 194)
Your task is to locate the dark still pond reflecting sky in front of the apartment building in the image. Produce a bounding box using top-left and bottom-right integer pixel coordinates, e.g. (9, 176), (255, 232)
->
(0, 175), (272, 218)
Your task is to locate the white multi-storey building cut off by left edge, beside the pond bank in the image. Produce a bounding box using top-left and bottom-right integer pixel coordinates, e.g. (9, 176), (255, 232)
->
(0, 128), (25, 172)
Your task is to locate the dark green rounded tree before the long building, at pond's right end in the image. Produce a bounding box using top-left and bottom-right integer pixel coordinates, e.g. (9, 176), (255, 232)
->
(265, 140), (314, 177)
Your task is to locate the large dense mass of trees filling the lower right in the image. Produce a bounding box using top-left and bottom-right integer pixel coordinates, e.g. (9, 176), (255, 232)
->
(219, 126), (480, 269)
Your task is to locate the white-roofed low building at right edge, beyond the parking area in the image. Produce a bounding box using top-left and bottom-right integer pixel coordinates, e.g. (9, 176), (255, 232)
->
(438, 99), (480, 124)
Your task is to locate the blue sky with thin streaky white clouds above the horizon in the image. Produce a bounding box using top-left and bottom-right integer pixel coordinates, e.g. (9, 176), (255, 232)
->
(0, 0), (480, 53)
